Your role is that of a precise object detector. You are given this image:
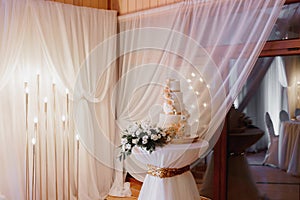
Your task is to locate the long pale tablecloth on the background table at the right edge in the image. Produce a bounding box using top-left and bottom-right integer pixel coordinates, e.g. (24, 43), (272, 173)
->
(279, 121), (300, 176)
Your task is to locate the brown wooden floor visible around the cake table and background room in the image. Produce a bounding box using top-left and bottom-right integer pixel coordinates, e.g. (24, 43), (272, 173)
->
(107, 152), (300, 200)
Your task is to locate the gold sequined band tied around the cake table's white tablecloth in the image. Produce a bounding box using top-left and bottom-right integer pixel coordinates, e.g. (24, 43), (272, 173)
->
(147, 164), (190, 178)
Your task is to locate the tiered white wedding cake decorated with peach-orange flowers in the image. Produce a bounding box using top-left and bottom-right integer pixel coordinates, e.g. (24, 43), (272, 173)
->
(157, 79), (189, 138)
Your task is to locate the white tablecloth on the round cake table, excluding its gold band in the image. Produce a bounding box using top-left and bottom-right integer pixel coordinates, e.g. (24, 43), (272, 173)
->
(133, 140), (208, 200)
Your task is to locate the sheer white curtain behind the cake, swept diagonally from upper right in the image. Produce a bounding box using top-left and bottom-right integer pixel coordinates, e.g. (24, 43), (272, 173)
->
(116, 0), (283, 183)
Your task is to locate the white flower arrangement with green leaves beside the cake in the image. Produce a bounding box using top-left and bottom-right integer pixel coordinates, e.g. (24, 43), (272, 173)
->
(119, 121), (172, 160)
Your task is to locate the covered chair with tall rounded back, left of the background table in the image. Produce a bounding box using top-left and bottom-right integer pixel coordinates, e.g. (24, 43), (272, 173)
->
(263, 112), (279, 167)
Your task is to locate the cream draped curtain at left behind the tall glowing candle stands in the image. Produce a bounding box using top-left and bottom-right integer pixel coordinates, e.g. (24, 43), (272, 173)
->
(0, 0), (117, 199)
